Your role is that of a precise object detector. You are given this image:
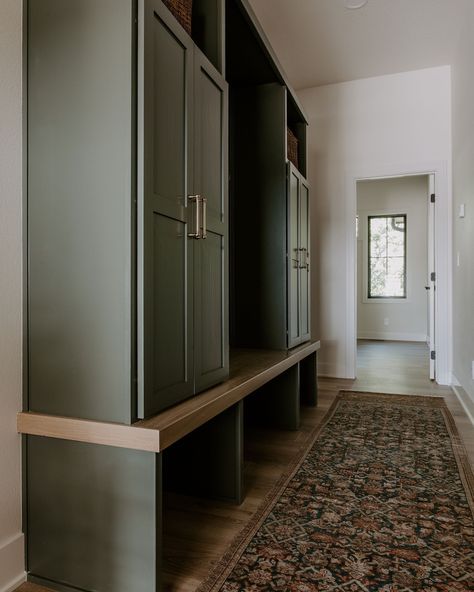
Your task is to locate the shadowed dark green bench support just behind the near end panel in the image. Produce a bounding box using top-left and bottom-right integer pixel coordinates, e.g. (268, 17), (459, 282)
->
(163, 401), (243, 504)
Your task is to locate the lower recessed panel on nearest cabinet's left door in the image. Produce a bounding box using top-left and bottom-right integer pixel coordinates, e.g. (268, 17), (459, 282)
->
(153, 214), (189, 407)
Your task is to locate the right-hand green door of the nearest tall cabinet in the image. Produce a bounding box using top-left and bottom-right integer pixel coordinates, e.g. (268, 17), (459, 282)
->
(193, 49), (229, 392)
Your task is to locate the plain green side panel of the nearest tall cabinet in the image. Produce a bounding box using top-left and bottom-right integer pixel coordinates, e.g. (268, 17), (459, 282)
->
(28, 0), (134, 423)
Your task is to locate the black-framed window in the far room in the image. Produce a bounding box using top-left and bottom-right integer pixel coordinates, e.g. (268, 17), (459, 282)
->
(367, 214), (407, 298)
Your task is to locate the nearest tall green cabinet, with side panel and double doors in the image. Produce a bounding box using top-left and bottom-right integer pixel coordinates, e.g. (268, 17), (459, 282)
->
(27, 0), (228, 423)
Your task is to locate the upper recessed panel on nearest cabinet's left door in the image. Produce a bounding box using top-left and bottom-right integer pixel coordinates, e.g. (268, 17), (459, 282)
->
(153, 13), (190, 203)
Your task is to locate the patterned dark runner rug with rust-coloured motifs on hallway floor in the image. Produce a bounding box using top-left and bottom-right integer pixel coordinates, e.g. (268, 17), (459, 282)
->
(198, 391), (474, 592)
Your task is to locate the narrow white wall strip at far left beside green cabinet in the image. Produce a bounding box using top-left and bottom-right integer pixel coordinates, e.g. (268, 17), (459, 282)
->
(0, 0), (24, 592)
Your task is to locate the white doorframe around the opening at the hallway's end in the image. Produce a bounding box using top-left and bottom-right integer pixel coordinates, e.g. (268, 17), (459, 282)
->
(345, 162), (452, 385)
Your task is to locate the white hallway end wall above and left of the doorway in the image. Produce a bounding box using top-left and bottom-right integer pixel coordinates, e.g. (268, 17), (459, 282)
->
(299, 67), (451, 377)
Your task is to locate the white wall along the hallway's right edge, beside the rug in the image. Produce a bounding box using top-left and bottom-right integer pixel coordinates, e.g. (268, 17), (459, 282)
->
(452, 0), (474, 405)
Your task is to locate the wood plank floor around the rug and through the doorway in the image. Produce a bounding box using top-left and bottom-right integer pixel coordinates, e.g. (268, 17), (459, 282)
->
(18, 341), (474, 592)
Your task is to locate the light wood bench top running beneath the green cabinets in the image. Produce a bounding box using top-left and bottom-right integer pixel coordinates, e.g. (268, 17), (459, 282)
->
(17, 341), (320, 452)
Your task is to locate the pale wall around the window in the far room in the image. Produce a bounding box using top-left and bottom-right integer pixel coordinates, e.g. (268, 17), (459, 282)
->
(357, 176), (429, 340)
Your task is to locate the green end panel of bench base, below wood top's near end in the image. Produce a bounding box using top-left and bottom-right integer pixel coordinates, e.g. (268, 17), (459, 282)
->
(26, 436), (162, 592)
